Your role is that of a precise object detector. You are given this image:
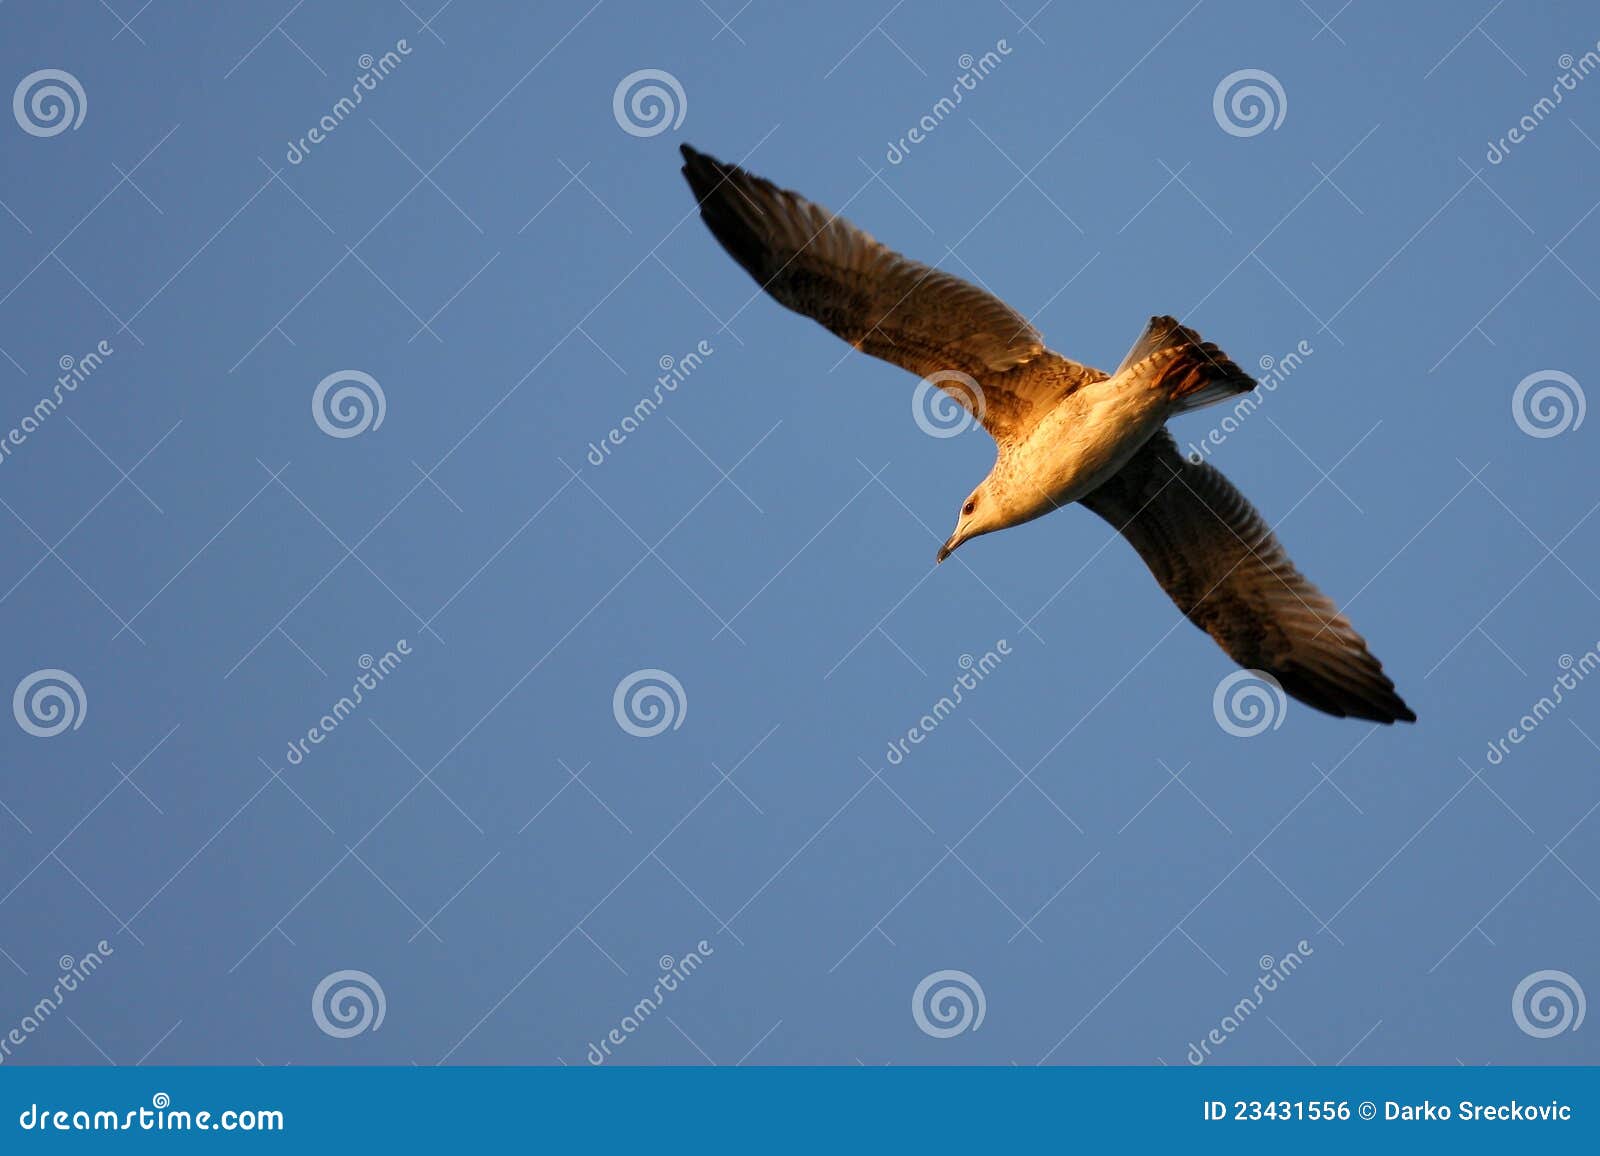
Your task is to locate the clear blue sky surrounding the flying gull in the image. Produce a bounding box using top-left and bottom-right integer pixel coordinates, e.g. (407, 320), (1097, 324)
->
(0, 0), (1600, 1063)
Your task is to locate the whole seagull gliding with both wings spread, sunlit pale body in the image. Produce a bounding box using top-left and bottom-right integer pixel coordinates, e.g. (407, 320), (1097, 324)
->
(682, 144), (1416, 724)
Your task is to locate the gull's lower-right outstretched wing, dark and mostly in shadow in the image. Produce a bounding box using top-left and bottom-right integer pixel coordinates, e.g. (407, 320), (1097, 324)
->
(1082, 429), (1416, 722)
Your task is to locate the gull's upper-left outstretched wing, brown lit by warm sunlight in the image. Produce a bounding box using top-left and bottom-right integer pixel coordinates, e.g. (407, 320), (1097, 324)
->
(682, 144), (1102, 439)
